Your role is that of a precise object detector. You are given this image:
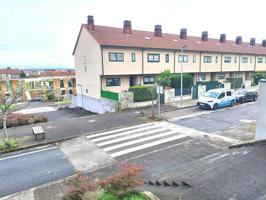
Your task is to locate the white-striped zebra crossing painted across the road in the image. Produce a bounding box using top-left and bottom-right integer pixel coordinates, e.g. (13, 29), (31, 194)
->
(87, 122), (191, 158)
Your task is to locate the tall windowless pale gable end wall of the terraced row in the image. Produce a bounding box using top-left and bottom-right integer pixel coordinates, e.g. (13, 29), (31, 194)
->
(74, 28), (102, 99)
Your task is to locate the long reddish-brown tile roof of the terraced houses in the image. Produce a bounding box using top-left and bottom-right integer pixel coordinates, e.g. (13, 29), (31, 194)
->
(79, 24), (266, 55)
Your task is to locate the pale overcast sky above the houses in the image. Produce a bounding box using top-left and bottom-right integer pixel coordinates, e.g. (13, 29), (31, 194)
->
(0, 0), (266, 68)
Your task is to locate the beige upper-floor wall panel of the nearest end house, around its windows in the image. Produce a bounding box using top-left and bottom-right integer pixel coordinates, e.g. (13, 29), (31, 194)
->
(103, 48), (142, 75)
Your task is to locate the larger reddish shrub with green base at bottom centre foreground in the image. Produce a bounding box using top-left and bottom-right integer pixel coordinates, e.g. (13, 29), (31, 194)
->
(101, 163), (144, 198)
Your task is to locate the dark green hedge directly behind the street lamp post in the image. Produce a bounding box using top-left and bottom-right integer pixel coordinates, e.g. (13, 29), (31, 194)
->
(171, 74), (194, 88)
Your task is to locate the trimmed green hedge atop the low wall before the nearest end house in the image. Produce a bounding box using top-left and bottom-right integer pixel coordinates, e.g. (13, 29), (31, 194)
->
(129, 85), (157, 102)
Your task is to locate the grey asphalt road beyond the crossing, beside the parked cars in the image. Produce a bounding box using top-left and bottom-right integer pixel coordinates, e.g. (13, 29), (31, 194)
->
(172, 102), (257, 133)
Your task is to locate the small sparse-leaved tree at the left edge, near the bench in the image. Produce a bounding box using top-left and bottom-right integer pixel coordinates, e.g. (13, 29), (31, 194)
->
(0, 85), (22, 140)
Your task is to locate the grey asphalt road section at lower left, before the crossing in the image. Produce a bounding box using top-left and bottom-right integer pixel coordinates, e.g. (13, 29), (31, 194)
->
(0, 146), (74, 197)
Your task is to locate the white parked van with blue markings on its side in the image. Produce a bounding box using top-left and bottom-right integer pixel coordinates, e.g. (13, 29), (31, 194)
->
(197, 88), (236, 110)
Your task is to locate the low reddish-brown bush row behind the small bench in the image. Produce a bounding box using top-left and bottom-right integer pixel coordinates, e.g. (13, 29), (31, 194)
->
(0, 113), (48, 129)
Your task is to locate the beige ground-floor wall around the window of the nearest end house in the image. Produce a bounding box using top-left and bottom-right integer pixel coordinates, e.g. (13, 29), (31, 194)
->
(102, 76), (129, 93)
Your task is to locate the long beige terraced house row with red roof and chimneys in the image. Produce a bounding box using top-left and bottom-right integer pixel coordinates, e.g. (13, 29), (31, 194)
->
(73, 16), (266, 112)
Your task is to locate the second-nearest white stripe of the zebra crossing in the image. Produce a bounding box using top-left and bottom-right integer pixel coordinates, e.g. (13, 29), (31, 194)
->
(103, 131), (178, 151)
